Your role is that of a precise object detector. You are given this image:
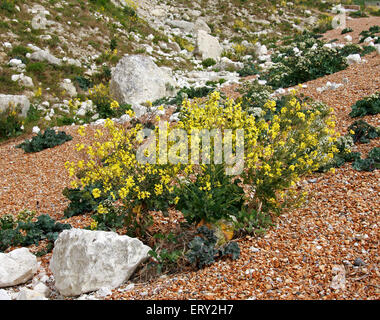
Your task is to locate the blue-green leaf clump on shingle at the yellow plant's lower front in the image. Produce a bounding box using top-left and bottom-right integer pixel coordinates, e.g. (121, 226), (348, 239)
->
(186, 226), (240, 269)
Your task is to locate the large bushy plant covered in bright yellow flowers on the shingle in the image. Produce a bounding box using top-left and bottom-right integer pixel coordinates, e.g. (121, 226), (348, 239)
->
(67, 91), (338, 236)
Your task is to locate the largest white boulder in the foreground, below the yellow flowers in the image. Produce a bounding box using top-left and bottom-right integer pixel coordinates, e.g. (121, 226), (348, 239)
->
(50, 229), (151, 296)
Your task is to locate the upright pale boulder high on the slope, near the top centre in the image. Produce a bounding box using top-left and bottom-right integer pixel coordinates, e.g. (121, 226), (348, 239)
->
(194, 30), (223, 60)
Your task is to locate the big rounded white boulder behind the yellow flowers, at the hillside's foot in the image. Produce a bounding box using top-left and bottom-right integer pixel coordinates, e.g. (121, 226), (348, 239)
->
(110, 55), (176, 105)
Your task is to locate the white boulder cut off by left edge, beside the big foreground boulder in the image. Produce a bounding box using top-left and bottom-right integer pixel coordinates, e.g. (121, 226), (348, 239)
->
(0, 248), (38, 288)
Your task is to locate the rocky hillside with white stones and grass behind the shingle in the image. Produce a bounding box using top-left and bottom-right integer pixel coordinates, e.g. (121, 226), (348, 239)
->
(0, 0), (350, 132)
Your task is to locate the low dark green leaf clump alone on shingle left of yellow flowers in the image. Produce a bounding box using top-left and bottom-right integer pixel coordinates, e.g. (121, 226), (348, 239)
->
(16, 128), (73, 153)
